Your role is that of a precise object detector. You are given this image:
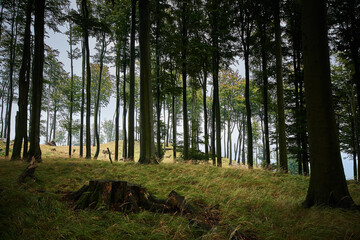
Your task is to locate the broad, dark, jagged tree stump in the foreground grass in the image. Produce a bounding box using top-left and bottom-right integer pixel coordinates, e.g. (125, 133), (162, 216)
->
(68, 180), (191, 213)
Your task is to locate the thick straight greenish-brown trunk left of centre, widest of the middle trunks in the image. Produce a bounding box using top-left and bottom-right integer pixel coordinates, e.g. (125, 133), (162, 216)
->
(139, 0), (155, 164)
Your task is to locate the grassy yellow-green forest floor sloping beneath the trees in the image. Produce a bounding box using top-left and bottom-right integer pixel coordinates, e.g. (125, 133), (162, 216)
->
(0, 142), (360, 240)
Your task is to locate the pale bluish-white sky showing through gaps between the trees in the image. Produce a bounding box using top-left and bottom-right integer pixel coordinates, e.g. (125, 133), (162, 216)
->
(4, 1), (354, 179)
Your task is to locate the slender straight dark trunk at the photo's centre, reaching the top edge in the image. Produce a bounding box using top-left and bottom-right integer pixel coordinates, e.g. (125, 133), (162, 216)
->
(181, 1), (189, 160)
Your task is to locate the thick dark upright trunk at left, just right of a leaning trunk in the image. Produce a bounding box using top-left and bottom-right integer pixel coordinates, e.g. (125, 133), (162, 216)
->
(28, 0), (45, 162)
